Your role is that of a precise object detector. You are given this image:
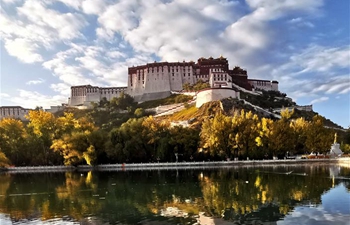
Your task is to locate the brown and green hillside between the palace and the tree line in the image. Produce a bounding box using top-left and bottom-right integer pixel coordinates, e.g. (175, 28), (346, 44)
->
(56, 89), (342, 130)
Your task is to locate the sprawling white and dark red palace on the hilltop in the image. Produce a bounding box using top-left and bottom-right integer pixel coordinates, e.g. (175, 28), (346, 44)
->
(68, 56), (278, 107)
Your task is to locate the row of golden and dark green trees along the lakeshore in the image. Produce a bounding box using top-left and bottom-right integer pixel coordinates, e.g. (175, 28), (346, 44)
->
(0, 99), (350, 166)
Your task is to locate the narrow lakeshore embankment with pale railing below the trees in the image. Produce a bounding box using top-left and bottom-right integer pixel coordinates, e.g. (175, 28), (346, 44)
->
(0, 157), (350, 173)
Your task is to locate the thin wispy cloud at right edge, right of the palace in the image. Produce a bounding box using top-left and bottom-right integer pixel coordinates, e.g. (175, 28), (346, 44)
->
(272, 45), (350, 98)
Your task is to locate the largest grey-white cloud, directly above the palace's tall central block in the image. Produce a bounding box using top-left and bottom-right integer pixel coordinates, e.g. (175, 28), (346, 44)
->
(96, 0), (323, 69)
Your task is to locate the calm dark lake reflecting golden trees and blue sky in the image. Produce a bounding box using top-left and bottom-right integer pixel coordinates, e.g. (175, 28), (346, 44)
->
(0, 165), (350, 225)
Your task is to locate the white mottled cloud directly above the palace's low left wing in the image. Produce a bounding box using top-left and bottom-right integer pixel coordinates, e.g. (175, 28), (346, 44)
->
(43, 44), (152, 90)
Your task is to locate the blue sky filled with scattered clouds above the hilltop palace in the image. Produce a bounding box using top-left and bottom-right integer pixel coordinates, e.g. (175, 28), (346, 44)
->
(0, 0), (350, 128)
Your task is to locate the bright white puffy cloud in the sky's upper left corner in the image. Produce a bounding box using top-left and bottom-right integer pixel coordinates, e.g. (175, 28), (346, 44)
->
(0, 0), (87, 63)
